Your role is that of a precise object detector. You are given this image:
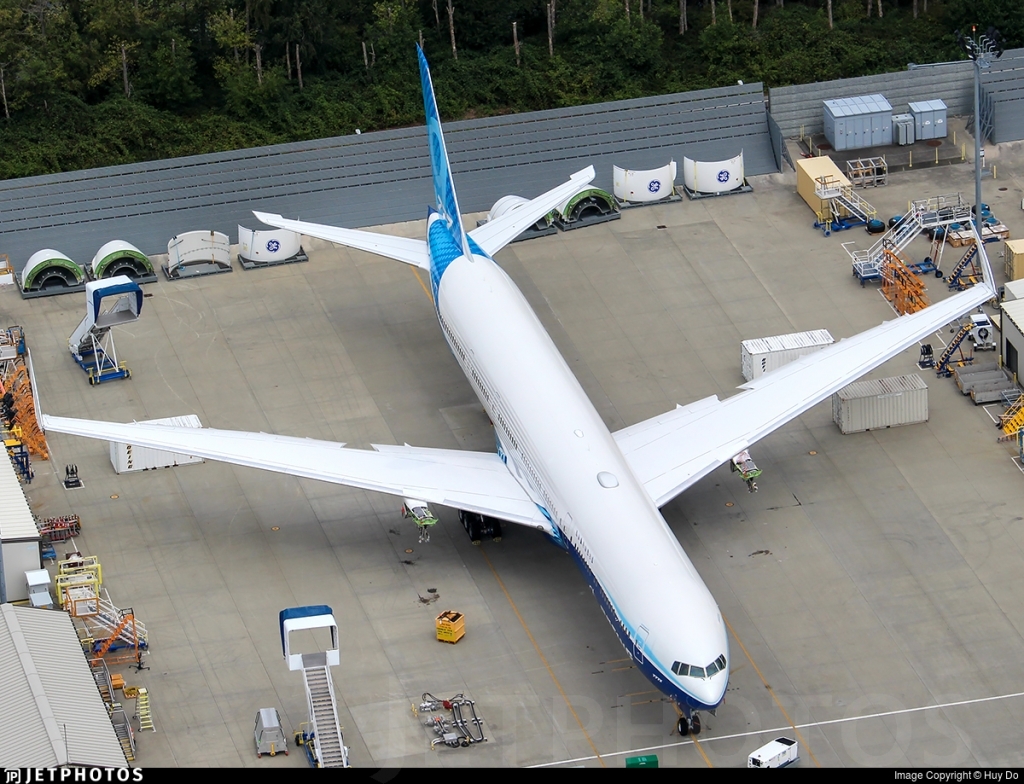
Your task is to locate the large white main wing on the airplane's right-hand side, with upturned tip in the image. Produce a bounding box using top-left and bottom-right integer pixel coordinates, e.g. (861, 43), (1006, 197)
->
(614, 258), (995, 507)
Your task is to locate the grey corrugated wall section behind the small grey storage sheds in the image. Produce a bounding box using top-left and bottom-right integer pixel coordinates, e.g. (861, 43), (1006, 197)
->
(768, 62), (974, 137)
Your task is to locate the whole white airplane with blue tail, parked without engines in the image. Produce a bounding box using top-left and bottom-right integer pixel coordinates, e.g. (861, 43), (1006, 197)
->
(43, 51), (994, 734)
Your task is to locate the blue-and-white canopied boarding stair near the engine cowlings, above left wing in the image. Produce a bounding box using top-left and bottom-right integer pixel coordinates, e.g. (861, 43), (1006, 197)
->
(68, 275), (142, 385)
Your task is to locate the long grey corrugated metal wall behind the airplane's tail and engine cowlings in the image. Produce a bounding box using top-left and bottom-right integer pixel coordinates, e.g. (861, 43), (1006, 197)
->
(0, 83), (778, 269)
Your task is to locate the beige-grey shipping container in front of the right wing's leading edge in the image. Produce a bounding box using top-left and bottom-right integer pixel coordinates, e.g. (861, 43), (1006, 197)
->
(833, 374), (928, 433)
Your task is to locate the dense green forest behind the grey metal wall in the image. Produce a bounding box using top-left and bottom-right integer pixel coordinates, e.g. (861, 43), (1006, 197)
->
(0, 0), (1024, 179)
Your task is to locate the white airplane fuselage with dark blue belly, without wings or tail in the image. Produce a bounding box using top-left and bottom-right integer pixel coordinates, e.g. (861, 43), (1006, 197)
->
(431, 215), (729, 710)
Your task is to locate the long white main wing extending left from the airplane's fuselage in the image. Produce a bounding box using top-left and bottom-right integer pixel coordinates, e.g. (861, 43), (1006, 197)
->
(42, 415), (554, 534)
